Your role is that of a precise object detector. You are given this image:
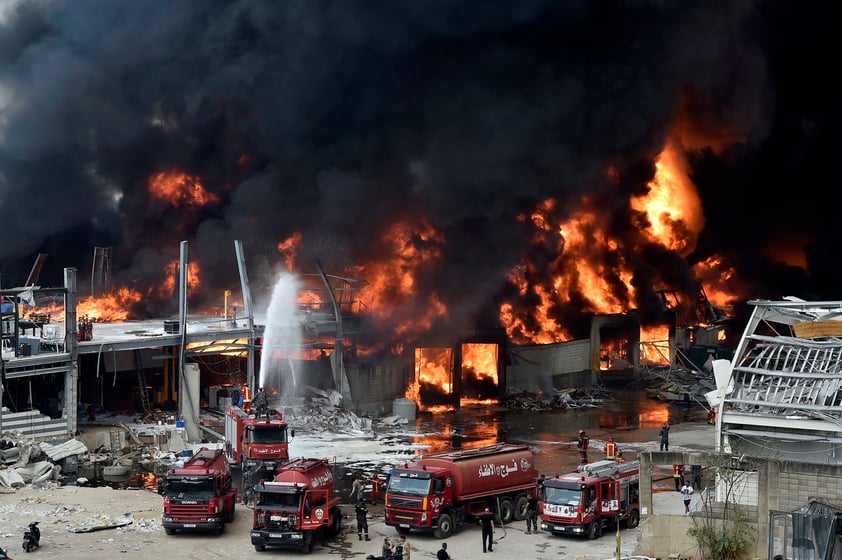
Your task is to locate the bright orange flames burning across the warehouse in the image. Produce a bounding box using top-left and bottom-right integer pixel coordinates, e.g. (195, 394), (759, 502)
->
(23, 129), (735, 409)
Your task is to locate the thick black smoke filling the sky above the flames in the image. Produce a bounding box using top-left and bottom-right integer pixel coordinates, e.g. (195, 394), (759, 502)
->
(0, 0), (842, 342)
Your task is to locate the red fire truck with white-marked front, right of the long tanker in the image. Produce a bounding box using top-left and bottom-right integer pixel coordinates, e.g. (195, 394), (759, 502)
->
(540, 461), (640, 539)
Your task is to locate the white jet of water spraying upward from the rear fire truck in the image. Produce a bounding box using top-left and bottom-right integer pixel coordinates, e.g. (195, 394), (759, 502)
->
(259, 273), (301, 404)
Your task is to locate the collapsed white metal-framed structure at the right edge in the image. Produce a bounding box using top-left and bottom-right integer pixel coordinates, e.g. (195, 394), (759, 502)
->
(721, 299), (842, 463)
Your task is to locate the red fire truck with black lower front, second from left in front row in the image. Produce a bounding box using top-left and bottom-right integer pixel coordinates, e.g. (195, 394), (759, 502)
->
(251, 459), (342, 553)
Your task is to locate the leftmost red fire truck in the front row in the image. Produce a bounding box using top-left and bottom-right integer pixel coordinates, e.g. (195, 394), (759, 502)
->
(159, 447), (237, 535)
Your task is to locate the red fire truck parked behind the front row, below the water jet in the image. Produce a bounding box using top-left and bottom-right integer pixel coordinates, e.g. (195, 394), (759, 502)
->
(225, 405), (295, 473)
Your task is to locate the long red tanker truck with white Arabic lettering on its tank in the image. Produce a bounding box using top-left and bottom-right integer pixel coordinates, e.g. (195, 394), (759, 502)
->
(385, 443), (538, 539)
